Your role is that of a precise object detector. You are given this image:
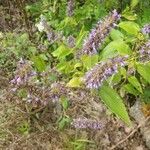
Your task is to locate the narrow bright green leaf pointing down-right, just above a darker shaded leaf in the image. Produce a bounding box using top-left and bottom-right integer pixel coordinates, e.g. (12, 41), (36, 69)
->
(128, 76), (143, 93)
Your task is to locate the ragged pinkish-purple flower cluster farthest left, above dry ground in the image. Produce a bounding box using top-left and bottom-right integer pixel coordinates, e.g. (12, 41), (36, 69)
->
(10, 59), (37, 86)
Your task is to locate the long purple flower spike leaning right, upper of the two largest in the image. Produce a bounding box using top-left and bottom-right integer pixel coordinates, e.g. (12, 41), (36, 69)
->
(82, 10), (121, 54)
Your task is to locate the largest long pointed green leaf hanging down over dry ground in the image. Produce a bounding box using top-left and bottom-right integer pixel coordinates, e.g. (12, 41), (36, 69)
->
(99, 86), (131, 125)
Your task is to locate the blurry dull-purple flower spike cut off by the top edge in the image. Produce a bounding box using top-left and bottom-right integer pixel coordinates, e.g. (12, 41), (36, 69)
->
(67, 0), (75, 17)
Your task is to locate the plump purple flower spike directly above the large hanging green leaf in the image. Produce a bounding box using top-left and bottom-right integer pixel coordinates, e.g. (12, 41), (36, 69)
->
(83, 56), (128, 89)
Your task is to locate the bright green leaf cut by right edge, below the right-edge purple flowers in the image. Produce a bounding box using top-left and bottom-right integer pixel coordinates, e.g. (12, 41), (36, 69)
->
(137, 64), (150, 83)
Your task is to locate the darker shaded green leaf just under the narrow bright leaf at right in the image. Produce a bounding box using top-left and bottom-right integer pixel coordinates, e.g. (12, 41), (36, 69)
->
(123, 83), (139, 96)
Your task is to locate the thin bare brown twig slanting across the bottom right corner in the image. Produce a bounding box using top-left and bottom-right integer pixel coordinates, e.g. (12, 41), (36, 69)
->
(110, 116), (150, 150)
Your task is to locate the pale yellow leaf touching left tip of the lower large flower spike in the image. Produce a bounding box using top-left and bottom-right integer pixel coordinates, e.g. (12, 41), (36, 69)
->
(67, 77), (82, 87)
